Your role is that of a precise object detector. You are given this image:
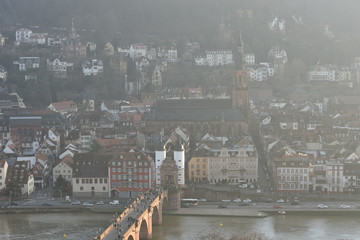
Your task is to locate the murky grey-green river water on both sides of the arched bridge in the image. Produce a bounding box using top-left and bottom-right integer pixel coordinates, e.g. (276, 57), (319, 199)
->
(0, 213), (360, 240)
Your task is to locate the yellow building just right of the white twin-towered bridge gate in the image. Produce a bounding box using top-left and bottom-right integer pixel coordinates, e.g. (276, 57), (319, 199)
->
(188, 149), (209, 182)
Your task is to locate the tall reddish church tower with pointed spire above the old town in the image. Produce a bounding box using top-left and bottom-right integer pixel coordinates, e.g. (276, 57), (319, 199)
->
(232, 32), (250, 122)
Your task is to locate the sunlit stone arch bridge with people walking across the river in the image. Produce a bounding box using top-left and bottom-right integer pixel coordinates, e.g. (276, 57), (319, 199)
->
(94, 189), (167, 240)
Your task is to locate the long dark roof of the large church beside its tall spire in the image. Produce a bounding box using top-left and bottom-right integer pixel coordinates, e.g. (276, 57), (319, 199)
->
(148, 99), (246, 122)
